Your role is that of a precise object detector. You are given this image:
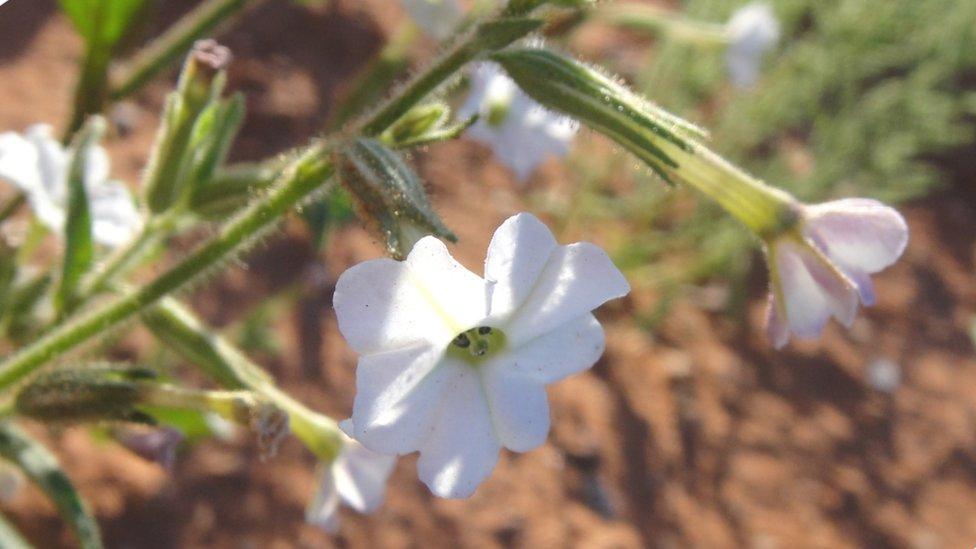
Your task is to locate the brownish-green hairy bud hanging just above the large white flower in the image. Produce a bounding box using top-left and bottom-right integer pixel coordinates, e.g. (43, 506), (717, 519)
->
(335, 138), (457, 259)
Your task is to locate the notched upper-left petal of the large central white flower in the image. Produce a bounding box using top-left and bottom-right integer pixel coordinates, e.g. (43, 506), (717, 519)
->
(334, 236), (486, 354)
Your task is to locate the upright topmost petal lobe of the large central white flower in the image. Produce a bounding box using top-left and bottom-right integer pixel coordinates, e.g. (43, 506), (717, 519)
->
(485, 213), (558, 319)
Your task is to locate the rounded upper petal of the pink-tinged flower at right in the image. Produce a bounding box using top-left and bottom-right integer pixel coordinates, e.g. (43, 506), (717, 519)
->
(805, 198), (908, 274)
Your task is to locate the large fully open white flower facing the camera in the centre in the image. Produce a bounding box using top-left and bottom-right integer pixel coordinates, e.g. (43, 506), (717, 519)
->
(334, 213), (630, 498)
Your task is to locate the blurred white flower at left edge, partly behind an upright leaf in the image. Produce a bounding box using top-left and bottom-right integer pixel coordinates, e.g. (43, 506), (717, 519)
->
(0, 124), (142, 247)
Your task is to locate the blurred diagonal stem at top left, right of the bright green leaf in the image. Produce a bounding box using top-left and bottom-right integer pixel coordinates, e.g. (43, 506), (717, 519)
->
(109, 0), (262, 101)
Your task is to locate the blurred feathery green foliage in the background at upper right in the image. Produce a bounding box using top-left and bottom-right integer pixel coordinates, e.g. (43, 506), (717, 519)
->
(573, 0), (976, 308)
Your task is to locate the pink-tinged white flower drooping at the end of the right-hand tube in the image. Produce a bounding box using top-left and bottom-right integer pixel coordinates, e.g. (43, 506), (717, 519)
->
(767, 198), (908, 348)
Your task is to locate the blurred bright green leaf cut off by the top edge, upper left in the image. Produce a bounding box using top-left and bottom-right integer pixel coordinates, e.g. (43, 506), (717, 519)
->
(60, 0), (147, 49)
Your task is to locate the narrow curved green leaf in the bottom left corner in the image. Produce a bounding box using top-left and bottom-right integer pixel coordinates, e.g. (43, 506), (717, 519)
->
(0, 422), (102, 549)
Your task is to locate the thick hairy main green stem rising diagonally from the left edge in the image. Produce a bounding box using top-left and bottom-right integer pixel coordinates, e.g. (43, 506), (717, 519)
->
(0, 5), (538, 389)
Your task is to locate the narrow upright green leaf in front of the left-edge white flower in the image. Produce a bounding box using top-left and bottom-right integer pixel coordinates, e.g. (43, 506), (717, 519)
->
(54, 117), (105, 314)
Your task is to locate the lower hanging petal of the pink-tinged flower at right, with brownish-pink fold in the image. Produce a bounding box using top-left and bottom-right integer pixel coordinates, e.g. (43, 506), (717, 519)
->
(772, 238), (857, 338)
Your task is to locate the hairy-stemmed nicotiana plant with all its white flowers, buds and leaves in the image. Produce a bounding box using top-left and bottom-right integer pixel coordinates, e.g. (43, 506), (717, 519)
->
(0, 0), (908, 547)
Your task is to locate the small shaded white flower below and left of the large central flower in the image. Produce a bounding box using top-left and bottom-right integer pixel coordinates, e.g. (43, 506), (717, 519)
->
(305, 420), (396, 533)
